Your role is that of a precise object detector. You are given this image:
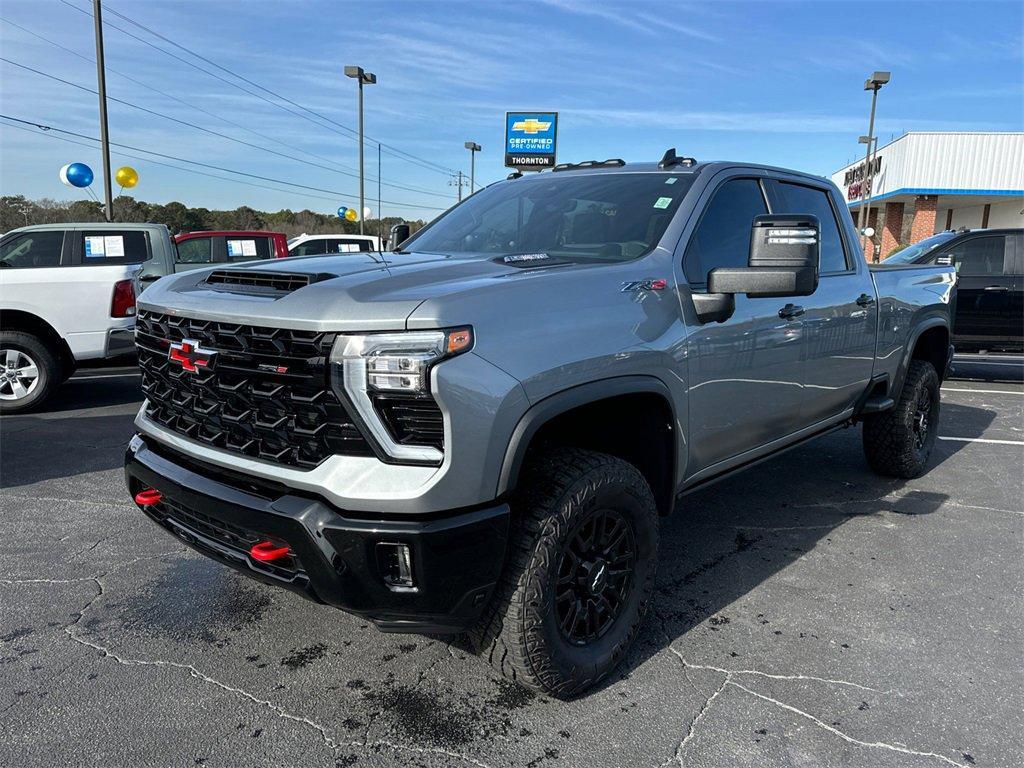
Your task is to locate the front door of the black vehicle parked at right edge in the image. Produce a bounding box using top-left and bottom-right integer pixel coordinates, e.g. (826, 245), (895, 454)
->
(936, 233), (1020, 347)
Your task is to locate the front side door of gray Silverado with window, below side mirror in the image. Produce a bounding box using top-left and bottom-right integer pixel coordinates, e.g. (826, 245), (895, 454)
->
(682, 176), (803, 476)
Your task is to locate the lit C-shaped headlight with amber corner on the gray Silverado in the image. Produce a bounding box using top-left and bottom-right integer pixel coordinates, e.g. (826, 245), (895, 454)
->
(331, 328), (473, 463)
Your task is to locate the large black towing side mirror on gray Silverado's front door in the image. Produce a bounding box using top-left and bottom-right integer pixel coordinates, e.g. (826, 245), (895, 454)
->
(708, 215), (821, 298)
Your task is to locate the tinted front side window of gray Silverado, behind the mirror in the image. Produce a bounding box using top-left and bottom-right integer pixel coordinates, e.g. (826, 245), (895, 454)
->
(683, 178), (768, 284)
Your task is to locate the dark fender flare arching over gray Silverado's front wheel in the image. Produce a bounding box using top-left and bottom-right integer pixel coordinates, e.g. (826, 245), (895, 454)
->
(498, 375), (679, 497)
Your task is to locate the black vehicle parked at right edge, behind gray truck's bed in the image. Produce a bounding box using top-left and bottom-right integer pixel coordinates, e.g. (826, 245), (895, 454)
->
(882, 229), (1024, 350)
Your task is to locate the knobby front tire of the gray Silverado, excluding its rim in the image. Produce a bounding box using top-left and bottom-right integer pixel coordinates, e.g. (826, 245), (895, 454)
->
(470, 447), (658, 698)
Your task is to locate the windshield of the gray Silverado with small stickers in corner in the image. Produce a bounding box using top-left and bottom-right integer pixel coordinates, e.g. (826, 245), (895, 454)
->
(402, 172), (693, 261)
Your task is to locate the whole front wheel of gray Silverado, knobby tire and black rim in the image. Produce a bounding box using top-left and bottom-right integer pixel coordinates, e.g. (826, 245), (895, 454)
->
(471, 449), (658, 697)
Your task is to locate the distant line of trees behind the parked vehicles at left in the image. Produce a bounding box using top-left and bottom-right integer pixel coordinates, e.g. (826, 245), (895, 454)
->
(0, 195), (425, 238)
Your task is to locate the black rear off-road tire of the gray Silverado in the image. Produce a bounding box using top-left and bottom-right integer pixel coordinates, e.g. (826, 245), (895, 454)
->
(863, 360), (939, 479)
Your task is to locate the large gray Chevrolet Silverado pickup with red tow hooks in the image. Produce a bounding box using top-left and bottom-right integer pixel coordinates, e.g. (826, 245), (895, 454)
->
(125, 151), (955, 697)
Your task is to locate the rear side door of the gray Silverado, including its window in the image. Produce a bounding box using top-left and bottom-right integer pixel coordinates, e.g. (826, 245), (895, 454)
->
(767, 178), (878, 427)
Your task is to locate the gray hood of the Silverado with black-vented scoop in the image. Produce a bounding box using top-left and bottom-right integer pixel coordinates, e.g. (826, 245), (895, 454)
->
(138, 253), (581, 331)
